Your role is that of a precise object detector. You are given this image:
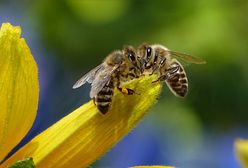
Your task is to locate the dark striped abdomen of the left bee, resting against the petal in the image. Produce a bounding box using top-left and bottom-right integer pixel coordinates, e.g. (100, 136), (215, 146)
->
(94, 80), (114, 114)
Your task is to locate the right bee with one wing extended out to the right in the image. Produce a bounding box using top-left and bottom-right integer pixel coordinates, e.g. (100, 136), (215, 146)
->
(137, 44), (206, 97)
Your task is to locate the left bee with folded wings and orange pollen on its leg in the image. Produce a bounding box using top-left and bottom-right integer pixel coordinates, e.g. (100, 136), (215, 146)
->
(72, 46), (141, 114)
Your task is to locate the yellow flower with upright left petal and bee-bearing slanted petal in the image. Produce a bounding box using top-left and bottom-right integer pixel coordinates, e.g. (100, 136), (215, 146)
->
(0, 23), (173, 168)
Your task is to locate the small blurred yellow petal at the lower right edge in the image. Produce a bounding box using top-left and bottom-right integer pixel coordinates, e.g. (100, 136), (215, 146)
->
(235, 139), (248, 167)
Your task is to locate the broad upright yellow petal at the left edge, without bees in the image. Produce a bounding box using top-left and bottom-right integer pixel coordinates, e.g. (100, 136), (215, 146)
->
(0, 23), (39, 161)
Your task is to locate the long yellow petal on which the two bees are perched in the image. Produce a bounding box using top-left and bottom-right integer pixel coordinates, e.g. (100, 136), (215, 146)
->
(2, 76), (161, 168)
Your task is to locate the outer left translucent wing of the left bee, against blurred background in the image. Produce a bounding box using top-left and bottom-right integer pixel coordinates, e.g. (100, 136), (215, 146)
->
(72, 64), (104, 89)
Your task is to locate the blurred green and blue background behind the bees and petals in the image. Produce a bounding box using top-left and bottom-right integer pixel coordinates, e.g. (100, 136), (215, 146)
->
(0, 0), (248, 168)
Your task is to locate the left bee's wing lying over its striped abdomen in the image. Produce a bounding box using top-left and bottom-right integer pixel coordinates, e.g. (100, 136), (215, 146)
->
(90, 65), (119, 98)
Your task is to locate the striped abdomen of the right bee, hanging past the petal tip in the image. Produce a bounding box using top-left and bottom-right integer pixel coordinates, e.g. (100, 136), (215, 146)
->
(166, 63), (188, 97)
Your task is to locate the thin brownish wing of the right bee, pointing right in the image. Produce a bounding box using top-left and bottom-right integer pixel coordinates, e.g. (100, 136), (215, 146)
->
(169, 51), (207, 64)
